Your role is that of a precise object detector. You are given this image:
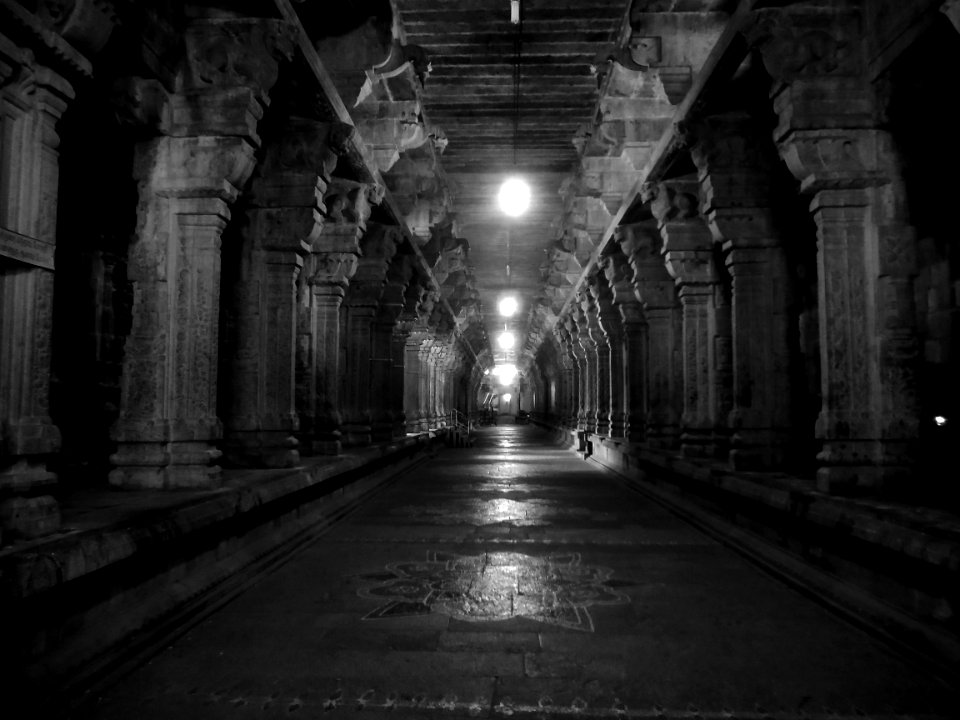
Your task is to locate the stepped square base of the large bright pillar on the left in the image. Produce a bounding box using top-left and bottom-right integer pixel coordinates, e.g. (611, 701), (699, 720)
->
(107, 442), (222, 489)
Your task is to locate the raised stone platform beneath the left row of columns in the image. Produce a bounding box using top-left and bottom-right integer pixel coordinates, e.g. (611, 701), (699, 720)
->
(0, 433), (440, 694)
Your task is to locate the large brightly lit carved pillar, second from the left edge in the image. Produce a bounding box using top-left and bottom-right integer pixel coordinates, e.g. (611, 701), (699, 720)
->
(110, 19), (293, 488)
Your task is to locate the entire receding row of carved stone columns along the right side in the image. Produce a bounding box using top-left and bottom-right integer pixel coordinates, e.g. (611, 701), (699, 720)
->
(532, 6), (919, 492)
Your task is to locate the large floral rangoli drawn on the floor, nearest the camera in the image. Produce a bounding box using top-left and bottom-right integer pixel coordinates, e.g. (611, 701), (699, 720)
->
(358, 551), (633, 632)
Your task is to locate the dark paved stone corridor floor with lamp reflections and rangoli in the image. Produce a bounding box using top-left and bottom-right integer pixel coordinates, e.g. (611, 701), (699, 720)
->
(77, 425), (960, 720)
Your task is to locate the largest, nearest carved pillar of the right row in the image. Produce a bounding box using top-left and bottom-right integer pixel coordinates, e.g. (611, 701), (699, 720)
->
(747, 6), (919, 492)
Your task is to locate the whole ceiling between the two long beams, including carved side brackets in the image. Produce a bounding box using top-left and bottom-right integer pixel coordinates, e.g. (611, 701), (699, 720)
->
(308, 0), (737, 367)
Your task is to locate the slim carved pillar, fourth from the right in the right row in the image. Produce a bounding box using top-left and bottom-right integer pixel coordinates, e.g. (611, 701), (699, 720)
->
(620, 221), (683, 448)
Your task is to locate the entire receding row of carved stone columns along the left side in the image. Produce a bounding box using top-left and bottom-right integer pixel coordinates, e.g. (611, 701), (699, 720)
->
(0, 9), (467, 537)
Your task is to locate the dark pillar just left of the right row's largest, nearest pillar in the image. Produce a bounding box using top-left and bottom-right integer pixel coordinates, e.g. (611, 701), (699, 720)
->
(692, 115), (792, 469)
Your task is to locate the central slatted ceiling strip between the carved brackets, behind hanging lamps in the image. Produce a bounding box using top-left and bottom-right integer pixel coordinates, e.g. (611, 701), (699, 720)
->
(395, 0), (626, 368)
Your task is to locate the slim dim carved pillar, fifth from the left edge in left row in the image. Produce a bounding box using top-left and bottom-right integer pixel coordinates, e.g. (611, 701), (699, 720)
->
(342, 225), (402, 446)
